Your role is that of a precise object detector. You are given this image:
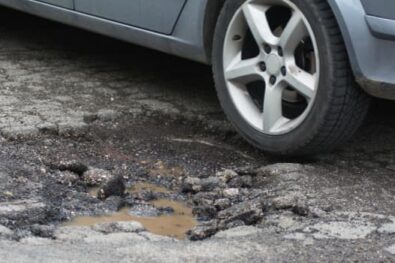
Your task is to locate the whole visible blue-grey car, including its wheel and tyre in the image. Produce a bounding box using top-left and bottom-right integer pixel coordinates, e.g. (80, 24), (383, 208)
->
(0, 0), (395, 156)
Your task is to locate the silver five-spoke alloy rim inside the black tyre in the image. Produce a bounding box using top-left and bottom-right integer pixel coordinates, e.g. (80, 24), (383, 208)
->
(223, 0), (320, 135)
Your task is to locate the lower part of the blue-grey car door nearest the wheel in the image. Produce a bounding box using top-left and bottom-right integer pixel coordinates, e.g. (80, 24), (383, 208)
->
(74, 0), (186, 34)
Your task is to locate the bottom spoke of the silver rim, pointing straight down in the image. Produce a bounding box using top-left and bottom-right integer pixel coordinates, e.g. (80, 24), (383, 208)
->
(263, 85), (283, 133)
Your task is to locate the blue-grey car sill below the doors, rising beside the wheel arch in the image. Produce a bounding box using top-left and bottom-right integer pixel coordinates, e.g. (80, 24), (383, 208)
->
(0, 0), (210, 63)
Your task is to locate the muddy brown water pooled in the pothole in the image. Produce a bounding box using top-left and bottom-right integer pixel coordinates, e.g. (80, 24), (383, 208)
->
(69, 183), (197, 239)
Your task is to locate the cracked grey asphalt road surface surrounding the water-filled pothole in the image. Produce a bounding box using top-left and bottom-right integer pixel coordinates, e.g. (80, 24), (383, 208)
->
(0, 8), (395, 262)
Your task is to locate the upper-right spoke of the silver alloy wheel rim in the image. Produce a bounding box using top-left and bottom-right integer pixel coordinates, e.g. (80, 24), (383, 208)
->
(280, 11), (309, 52)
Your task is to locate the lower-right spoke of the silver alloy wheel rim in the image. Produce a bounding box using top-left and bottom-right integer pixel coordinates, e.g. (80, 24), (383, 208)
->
(285, 69), (316, 100)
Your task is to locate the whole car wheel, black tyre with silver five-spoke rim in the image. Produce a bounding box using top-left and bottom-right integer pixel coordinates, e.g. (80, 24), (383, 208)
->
(213, 0), (369, 155)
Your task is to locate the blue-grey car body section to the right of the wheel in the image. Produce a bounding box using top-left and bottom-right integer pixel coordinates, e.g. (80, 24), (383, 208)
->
(328, 0), (395, 99)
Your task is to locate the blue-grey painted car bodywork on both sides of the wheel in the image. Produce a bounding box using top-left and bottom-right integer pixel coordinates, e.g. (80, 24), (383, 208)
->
(0, 0), (395, 99)
